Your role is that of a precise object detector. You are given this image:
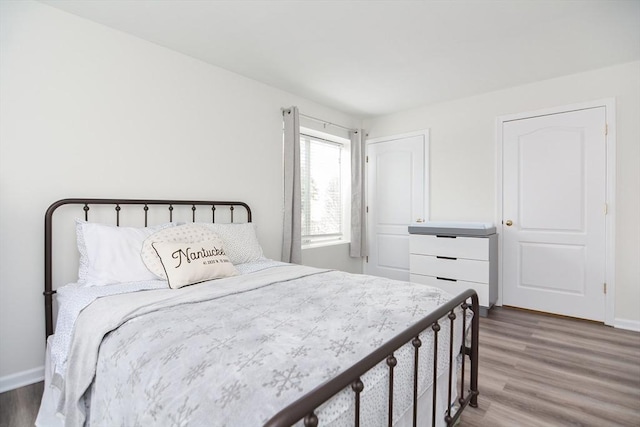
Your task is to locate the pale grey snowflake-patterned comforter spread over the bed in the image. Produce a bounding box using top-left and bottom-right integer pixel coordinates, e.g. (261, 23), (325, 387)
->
(59, 265), (461, 427)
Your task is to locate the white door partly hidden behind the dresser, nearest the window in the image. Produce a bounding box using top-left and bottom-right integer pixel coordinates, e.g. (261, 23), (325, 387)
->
(364, 133), (427, 280)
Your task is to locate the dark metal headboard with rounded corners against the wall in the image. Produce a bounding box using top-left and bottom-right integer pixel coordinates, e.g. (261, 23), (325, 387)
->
(43, 199), (251, 337)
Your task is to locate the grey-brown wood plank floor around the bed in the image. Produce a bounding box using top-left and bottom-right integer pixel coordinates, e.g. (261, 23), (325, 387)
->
(0, 308), (640, 427)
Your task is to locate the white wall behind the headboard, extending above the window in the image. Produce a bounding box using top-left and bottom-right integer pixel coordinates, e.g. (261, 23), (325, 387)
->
(0, 1), (360, 388)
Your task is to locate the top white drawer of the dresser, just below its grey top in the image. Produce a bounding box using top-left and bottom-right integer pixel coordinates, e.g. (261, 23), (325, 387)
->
(409, 234), (489, 261)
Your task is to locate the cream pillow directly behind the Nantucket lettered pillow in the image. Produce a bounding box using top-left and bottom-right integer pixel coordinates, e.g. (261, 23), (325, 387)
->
(141, 224), (219, 280)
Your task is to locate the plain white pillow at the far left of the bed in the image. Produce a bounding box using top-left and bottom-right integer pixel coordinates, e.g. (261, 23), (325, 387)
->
(76, 220), (175, 286)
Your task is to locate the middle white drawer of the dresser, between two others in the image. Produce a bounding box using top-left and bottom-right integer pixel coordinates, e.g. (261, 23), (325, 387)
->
(409, 254), (489, 283)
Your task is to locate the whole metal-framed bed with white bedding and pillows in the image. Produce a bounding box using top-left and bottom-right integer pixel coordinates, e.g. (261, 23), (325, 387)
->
(36, 199), (479, 427)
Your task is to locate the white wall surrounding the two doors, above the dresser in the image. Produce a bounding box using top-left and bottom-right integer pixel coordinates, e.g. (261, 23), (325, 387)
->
(363, 61), (640, 328)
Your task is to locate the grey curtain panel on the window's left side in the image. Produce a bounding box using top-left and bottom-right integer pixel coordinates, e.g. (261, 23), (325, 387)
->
(282, 107), (302, 264)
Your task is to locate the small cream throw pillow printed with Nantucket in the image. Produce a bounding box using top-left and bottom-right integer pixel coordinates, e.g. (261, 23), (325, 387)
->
(151, 239), (238, 289)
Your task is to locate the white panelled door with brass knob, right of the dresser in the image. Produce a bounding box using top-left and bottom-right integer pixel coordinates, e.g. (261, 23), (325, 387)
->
(502, 107), (606, 321)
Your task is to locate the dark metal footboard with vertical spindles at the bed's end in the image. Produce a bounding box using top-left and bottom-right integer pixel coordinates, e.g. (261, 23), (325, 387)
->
(265, 289), (480, 427)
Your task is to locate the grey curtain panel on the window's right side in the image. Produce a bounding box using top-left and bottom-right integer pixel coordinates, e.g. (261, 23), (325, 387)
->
(349, 129), (367, 258)
